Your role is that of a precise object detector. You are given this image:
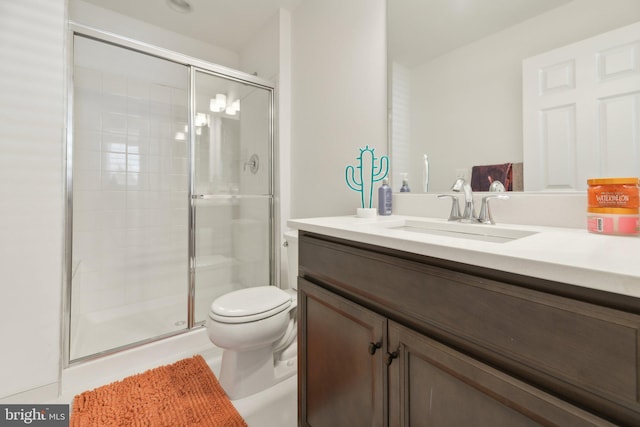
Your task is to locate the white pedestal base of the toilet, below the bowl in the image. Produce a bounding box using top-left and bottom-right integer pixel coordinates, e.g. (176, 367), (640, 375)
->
(219, 346), (297, 400)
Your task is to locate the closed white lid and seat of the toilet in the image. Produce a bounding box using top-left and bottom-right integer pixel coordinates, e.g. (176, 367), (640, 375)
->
(209, 286), (291, 323)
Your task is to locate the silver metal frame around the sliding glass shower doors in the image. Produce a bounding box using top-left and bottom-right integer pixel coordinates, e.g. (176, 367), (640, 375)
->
(61, 21), (280, 368)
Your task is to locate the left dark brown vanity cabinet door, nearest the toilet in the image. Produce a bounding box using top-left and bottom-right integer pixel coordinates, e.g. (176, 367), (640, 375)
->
(298, 279), (386, 427)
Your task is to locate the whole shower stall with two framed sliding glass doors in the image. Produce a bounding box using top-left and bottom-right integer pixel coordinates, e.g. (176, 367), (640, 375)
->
(65, 26), (279, 363)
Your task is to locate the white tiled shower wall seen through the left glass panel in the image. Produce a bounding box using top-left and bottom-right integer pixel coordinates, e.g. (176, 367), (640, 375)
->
(71, 36), (189, 359)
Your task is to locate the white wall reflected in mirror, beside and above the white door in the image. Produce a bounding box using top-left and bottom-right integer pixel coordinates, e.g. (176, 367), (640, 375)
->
(410, 0), (640, 191)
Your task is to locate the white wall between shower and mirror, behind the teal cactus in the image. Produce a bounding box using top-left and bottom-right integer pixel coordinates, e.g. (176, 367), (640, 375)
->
(291, 0), (387, 218)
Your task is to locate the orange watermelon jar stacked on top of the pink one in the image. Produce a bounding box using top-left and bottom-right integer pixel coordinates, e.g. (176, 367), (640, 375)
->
(587, 178), (640, 210)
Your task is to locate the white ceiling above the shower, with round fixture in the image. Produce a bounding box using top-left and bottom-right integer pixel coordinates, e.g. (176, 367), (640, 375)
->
(80, 0), (302, 52)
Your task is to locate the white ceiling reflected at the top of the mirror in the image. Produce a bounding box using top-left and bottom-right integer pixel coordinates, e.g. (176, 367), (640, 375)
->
(387, 0), (572, 67)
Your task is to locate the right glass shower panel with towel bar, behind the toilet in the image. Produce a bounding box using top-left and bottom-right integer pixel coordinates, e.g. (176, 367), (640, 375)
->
(192, 71), (274, 323)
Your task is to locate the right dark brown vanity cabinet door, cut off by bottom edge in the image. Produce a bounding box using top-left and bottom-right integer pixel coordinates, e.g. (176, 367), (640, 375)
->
(389, 321), (613, 427)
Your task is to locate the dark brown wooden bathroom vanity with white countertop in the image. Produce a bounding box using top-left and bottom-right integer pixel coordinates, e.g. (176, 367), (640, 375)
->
(289, 217), (640, 427)
